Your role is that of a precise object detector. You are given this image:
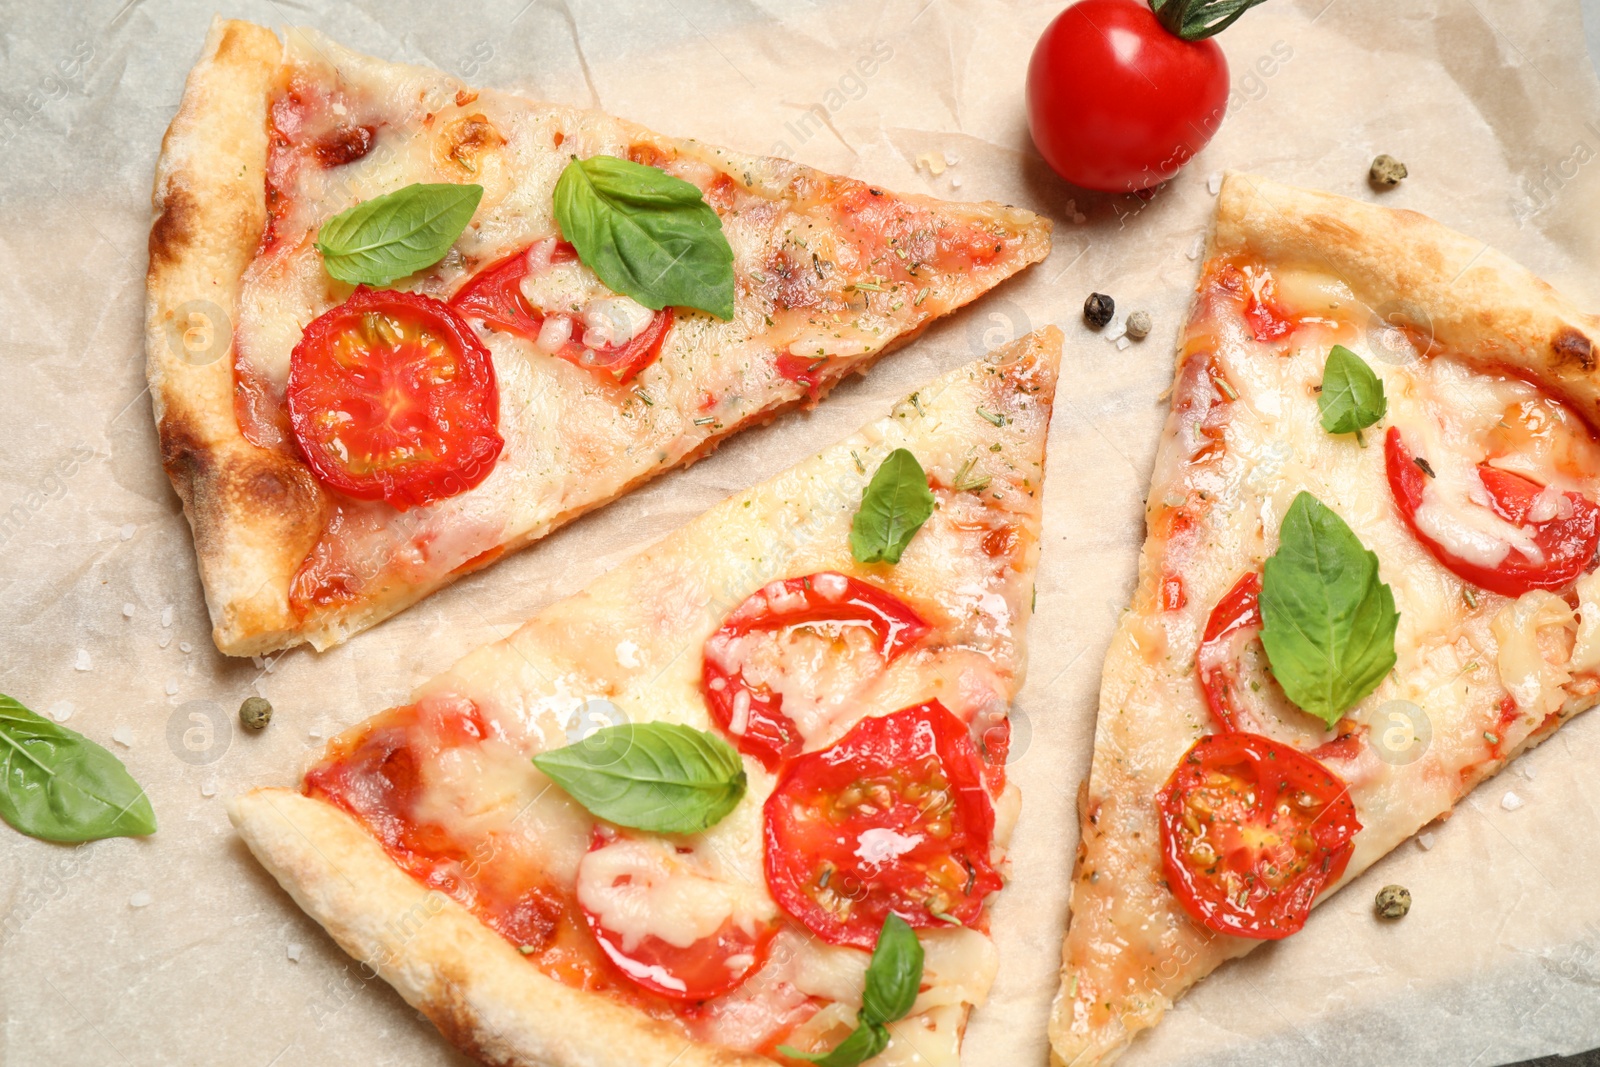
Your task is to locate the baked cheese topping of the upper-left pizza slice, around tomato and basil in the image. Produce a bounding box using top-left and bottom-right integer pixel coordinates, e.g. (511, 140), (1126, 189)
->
(235, 30), (1043, 646)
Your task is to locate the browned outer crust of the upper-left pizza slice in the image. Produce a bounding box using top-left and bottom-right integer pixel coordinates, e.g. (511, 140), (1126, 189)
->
(144, 19), (331, 656)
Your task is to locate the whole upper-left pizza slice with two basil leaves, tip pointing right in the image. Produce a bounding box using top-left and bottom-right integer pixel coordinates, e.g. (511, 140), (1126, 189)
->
(146, 21), (1050, 654)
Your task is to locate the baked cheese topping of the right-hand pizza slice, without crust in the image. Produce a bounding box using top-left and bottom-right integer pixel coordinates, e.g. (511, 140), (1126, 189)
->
(1053, 258), (1600, 1061)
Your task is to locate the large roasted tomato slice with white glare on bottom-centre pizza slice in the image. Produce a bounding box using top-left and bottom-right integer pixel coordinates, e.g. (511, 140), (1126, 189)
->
(765, 701), (1000, 949)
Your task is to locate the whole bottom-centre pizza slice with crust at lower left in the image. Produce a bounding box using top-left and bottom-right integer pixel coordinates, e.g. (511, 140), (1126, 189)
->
(229, 328), (1061, 1067)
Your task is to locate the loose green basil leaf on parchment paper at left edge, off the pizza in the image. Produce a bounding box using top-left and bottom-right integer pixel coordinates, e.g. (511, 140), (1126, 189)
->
(0, 694), (155, 841)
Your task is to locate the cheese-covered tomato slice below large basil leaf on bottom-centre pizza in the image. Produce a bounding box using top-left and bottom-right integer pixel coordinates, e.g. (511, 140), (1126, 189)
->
(578, 830), (778, 1000)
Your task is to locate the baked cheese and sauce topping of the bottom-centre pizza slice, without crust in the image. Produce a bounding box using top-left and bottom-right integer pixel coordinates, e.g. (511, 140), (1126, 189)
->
(306, 341), (1054, 1067)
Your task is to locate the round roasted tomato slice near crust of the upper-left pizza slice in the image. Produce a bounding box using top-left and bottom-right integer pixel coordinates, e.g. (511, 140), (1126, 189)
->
(288, 286), (506, 510)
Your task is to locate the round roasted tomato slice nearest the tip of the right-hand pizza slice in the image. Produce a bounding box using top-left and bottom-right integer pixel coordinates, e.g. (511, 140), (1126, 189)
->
(1157, 733), (1362, 941)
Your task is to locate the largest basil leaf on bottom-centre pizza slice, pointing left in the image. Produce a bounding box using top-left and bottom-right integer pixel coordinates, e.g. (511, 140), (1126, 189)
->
(533, 723), (746, 833)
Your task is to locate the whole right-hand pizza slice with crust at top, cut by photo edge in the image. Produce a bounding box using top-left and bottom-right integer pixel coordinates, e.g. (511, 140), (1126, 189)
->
(1050, 174), (1600, 1065)
